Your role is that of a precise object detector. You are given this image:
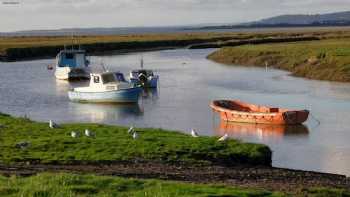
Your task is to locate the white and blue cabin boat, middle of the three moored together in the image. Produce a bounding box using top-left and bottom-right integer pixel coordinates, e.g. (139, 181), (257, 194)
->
(68, 72), (142, 103)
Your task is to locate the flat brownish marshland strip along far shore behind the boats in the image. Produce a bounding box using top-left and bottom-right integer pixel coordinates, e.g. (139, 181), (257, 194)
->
(0, 28), (350, 61)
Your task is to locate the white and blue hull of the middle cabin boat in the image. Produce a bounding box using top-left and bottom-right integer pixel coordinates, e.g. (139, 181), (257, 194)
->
(68, 87), (142, 103)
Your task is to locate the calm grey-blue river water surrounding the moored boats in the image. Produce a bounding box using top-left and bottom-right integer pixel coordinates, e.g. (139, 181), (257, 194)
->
(0, 49), (350, 175)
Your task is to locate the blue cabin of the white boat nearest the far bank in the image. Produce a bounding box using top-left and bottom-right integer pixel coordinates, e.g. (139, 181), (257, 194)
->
(56, 50), (89, 68)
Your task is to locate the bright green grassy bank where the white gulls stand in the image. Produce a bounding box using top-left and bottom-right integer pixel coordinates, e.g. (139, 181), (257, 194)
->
(0, 115), (271, 165)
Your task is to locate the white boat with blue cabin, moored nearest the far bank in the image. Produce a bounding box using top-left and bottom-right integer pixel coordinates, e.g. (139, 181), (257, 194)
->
(55, 49), (91, 80)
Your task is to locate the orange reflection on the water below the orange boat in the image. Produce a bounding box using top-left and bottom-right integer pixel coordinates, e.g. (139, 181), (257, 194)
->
(215, 121), (309, 141)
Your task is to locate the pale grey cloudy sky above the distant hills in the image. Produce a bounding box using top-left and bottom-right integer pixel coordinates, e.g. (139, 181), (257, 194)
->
(0, 0), (350, 32)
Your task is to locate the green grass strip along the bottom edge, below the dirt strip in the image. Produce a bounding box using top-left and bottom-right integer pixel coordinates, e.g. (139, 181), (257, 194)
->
(0, 173), (350, 197)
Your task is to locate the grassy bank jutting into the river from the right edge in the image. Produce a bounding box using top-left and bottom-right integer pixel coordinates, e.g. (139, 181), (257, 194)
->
(208, 38), (350, 82)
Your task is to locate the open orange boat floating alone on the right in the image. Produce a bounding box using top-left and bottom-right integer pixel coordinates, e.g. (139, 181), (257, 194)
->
(210, 100), (309, 125)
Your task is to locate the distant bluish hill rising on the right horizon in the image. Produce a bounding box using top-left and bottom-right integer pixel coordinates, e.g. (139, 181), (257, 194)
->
(198, 11), (350, 29)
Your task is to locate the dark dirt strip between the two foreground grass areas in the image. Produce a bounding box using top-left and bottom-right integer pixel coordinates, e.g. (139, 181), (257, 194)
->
(0, 162), (350, 193)
